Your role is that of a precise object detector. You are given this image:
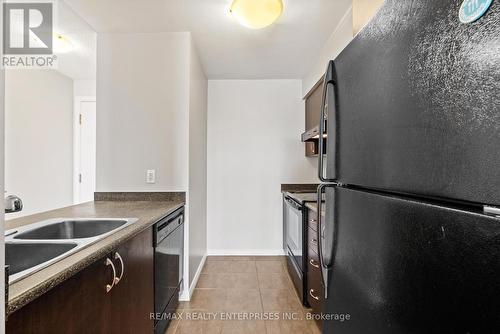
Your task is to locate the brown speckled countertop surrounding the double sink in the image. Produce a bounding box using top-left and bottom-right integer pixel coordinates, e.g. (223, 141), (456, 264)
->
(5, 199), (184, 315)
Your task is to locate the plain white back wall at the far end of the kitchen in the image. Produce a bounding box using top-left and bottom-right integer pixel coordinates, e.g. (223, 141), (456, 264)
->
(207, 80), (317, 255)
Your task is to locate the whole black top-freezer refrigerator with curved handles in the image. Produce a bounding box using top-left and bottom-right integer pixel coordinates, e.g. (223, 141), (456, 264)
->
(318, 0), (500, 334)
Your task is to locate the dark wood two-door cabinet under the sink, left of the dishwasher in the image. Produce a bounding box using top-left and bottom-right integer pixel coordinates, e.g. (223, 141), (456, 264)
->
(6, 229), (154, 334)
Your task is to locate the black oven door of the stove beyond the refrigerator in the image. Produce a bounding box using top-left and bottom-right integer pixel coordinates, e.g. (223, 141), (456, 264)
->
(284, 197), (304, 272)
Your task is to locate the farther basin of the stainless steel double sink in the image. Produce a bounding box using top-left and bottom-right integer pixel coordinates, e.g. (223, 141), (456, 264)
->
(14, 220), (127, 240)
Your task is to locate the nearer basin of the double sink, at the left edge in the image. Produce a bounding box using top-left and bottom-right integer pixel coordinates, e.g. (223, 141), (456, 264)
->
(5, 242), (77, 275)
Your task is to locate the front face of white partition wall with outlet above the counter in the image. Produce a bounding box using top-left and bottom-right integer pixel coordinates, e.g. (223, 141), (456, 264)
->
(97, 33), (190, 191)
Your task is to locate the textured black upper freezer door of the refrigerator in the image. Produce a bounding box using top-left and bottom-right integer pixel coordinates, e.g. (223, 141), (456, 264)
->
(325, 0), (500, 205)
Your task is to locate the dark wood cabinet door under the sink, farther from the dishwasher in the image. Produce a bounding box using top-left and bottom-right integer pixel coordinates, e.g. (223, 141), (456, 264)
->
(6, 254), (113, 334)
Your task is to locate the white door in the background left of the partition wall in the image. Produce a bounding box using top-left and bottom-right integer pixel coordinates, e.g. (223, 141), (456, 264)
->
(77, 100), (96, 203)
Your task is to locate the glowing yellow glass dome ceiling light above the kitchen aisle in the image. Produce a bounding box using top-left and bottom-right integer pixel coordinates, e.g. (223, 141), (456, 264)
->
(230, 0), (283, 29)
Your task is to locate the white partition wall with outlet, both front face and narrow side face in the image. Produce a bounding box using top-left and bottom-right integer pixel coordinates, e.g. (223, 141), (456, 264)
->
(96, 33), (207, 298)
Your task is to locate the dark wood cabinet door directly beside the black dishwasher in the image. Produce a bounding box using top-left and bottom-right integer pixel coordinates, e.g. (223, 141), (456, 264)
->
(110, 229), (154, 334)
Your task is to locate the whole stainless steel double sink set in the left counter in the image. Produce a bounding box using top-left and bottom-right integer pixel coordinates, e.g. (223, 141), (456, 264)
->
(5, 218), (137, 283)
